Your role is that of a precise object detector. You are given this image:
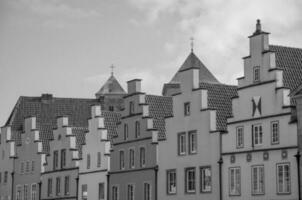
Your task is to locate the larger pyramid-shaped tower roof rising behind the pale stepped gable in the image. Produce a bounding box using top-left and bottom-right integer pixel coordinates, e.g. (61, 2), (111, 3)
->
(170, 52), (219, 83)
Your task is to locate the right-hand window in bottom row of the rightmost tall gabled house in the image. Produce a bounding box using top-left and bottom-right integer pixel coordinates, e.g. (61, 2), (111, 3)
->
(277, 163), (291, 194)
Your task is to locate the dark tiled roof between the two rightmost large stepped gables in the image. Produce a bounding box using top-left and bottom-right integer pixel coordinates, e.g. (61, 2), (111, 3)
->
(200, 83), (237, 131)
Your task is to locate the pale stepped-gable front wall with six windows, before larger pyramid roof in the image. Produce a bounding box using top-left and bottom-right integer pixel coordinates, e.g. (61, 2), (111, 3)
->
(158, 70), (220, 200)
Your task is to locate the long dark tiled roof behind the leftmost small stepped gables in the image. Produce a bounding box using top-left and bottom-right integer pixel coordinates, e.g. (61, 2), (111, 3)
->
(5, 94), (102, 152)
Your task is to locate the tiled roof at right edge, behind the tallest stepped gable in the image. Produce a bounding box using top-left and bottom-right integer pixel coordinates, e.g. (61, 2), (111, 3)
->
(269, 45), (302, 91)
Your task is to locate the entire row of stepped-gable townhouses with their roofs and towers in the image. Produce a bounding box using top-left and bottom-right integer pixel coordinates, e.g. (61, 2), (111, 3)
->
(0, 21), (302, 200)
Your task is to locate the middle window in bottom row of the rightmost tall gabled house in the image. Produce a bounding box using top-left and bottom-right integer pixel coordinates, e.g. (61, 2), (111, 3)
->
(252, 166), (264, 194)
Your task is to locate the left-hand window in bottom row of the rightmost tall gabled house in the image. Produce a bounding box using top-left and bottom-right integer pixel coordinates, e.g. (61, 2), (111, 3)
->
(229, 167), (241, 196)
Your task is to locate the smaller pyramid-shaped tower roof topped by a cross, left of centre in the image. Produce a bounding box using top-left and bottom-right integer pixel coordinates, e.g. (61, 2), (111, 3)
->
(95, 74), (126, 97)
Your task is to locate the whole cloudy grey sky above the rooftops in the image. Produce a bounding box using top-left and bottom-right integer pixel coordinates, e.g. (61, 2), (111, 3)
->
(0, 0), (302, 126)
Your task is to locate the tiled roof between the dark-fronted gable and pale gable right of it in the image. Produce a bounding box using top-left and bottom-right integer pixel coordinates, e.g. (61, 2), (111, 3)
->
(146, 95), (173, 139)
